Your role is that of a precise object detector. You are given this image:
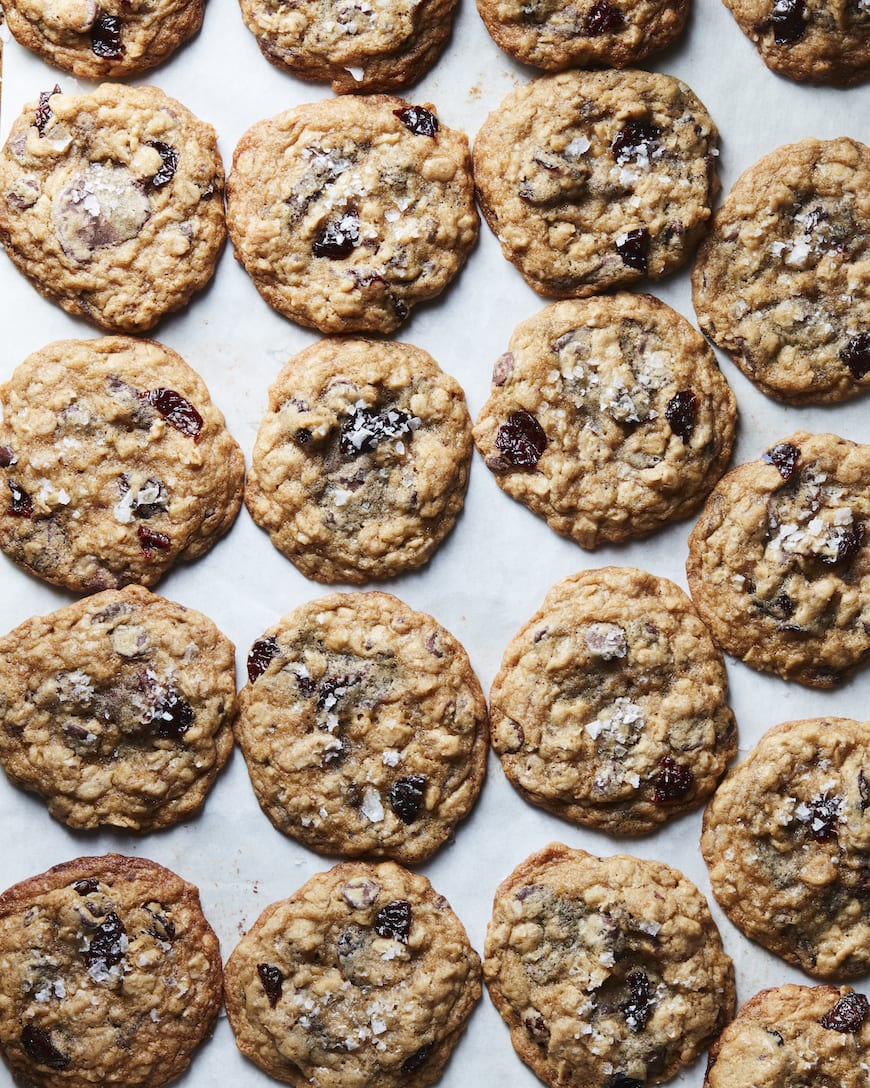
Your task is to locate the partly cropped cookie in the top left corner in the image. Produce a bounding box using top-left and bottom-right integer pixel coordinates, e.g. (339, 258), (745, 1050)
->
(3, 0), (206, 79)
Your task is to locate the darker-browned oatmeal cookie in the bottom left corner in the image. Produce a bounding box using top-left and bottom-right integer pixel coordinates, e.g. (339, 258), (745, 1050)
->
(0, 854), (221, 1088)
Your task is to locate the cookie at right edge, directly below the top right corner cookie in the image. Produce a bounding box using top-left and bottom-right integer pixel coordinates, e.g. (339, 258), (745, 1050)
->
(692, 139), (870, 405)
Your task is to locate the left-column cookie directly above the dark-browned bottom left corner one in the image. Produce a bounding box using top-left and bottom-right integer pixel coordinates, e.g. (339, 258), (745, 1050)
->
(0, 585), (236, 831)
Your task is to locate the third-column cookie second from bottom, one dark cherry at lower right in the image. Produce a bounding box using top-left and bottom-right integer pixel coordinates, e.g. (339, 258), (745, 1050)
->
(489, 567), (736, 834)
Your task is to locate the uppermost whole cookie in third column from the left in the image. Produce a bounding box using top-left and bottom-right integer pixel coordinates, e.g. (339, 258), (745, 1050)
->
(474, 71), (719, 298)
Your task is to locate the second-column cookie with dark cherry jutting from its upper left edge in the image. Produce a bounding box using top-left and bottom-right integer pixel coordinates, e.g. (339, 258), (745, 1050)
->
(236, 593), (486, 864)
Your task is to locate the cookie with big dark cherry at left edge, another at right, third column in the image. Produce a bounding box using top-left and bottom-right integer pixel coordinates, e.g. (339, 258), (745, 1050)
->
(474, 294), (736, 548)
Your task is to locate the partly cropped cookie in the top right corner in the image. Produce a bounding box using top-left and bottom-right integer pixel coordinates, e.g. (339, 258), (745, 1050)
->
(724, 0), (870, 87)
